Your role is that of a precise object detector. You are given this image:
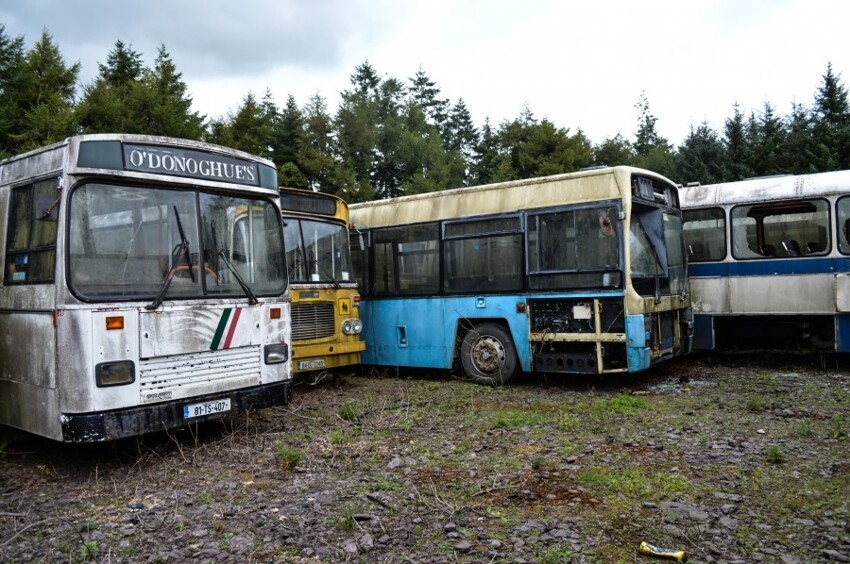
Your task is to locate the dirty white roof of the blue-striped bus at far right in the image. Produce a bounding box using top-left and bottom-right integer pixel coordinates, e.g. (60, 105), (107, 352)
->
(679, 170), (850, 209)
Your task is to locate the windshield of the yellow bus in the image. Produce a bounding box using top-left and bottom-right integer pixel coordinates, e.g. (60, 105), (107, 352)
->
(283, 217), (352, 283)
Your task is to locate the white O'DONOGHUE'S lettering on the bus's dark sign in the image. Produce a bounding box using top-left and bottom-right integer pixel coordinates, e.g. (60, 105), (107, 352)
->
(126, 148), (257, 183)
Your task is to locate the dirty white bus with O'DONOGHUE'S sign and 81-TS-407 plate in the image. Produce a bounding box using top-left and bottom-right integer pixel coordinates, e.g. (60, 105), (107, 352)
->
(0, 134), (292, 443)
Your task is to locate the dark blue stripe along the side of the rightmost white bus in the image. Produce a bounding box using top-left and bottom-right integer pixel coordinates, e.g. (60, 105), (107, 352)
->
(688, 258), (850, 278)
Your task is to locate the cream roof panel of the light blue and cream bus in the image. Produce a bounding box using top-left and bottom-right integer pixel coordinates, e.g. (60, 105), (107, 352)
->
(350, 166), (675, 228)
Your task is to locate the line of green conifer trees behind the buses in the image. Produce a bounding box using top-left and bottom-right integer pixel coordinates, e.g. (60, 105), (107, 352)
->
(0, 24), (850, 202)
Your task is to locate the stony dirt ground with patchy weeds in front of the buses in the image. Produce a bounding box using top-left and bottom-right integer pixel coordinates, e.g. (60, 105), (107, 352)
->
(0, 353), (850, 563)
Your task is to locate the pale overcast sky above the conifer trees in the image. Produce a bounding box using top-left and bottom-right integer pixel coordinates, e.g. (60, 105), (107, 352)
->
(0, 0), (850, 144)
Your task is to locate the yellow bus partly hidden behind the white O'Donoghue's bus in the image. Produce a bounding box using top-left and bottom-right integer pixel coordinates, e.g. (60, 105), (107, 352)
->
(280, 188), (366, 377)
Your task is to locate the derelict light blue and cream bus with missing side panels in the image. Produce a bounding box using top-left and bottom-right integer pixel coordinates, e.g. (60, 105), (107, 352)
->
(351, 166), (692, 385)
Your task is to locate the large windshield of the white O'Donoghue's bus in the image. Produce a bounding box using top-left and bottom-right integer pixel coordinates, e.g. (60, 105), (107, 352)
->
(68, 183), (286, 301)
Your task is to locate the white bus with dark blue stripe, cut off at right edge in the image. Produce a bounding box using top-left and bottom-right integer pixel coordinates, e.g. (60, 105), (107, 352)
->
(680, 171), (850, 352)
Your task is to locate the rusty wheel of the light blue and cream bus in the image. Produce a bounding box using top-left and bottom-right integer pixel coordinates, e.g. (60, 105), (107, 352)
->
(460, 323), (517, 386)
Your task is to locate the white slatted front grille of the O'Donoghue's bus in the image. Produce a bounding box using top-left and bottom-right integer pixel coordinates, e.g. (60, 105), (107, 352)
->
(139, 345), (262, 397)
